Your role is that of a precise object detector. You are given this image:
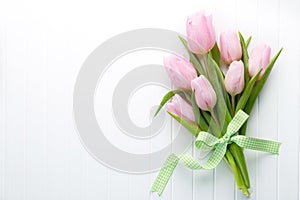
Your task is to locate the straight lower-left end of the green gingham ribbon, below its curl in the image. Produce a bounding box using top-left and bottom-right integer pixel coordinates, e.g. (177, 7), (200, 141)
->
(151, 154), (179, 196)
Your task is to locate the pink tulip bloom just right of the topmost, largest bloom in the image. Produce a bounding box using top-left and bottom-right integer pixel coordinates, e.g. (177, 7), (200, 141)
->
(220, 31), (242, 65)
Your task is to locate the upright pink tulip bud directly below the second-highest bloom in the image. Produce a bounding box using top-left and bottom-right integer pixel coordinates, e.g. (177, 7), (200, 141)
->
(224, 61), (245, 96)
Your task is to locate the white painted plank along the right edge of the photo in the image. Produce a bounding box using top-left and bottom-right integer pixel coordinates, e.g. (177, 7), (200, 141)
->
(277, 1), (300, 199)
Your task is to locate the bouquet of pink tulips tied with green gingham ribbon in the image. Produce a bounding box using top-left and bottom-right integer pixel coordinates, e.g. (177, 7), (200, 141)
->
(152, 13), (282, 196)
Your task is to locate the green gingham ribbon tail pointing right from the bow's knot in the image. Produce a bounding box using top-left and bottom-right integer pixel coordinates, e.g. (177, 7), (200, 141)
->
(232, 135), (281, 154)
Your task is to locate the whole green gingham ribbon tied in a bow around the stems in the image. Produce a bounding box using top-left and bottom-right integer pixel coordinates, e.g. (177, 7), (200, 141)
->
(151, 110), (281, 195)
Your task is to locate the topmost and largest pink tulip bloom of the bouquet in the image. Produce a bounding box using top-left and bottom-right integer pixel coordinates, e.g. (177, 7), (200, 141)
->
(186, 12), (216, 55)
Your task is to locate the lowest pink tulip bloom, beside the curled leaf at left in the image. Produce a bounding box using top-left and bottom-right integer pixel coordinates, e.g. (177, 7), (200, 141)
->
(166, 94), (195, 122)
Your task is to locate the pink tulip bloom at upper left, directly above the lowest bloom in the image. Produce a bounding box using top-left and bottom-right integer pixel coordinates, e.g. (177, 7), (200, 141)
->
(164, 55), (197, 89)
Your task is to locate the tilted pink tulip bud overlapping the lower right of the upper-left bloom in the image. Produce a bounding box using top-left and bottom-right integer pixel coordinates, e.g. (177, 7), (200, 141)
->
(191, 75), (217, 111)
